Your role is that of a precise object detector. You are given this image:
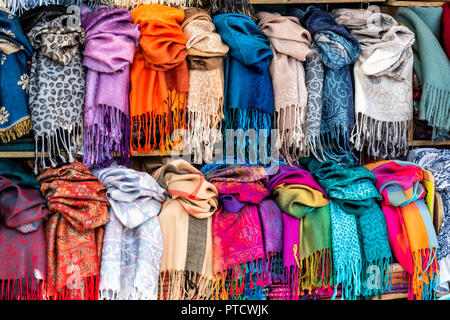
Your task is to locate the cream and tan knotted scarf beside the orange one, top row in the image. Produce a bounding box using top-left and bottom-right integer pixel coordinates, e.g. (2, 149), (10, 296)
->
(181, 8), (228, 163)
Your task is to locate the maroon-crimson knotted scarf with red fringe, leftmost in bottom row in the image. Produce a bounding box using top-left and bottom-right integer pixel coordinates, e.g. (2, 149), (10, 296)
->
(0, 159), (50, 300)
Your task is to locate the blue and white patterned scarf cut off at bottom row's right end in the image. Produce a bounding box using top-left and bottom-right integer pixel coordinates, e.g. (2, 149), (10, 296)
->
(408, 148), (450, 293)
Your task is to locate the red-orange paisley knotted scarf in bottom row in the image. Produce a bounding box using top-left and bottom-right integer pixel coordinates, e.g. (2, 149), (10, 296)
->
(37, 160), (109, 300)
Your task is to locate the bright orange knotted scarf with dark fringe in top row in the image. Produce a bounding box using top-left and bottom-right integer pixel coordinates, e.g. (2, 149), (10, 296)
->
(130, 4), (189, 153)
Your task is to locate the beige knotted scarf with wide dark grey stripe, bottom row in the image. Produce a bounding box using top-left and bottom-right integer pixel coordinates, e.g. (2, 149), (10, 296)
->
(153, 160), (218, 300)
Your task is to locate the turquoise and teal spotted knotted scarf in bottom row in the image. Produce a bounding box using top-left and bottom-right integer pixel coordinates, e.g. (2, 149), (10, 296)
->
(301, 158), (392, 299)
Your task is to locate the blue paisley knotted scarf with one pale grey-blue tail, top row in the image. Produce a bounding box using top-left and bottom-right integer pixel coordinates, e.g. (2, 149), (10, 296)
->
(288, 7), (360, 161)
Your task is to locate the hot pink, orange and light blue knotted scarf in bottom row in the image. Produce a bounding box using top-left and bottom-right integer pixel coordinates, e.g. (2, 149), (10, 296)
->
(365, 160), (439, 300)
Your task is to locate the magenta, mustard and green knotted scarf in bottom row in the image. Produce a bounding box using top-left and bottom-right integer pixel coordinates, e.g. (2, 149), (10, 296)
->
(267, 165), (333, 299)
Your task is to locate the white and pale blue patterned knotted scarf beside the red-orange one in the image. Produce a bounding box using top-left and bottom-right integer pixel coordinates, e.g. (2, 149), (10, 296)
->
(94, 165), (166, 300)
